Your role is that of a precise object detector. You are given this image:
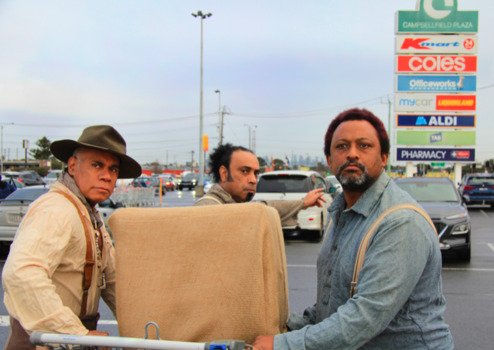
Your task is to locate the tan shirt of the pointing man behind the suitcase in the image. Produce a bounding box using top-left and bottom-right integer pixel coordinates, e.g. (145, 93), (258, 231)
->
(194, 184), (305, 226)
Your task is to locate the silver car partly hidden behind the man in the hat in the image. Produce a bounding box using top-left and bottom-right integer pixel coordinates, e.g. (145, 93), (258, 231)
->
(0, 185), (121, 245)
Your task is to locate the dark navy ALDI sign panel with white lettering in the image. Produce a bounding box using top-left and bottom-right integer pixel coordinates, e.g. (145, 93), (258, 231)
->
(396, 114), (475, 129)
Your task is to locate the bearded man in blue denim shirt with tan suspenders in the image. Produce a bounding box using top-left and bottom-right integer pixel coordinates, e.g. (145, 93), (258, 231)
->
(253, 108), (453, 350)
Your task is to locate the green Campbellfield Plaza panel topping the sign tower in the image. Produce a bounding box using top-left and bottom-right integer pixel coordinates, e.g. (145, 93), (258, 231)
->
(396, 0), (479, 33)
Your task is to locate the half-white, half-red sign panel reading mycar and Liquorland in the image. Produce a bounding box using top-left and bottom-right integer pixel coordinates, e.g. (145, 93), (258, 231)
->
(395, 94), (477, 112)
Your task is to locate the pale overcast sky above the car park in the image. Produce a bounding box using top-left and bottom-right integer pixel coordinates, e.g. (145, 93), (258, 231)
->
(0, 0), (494, 167)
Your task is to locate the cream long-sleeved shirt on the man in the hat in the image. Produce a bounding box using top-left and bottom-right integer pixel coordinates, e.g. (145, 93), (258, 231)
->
(2, 182), (115, 335)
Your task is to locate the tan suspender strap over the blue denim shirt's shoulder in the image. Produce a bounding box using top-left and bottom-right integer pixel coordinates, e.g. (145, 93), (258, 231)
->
(350, 204), (437, 298)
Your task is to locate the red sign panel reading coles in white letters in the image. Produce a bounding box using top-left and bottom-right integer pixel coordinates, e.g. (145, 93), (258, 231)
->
(396, 56), (477, 73)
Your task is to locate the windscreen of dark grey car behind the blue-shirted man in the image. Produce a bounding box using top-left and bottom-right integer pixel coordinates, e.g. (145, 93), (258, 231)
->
(397, 182), (459, 202)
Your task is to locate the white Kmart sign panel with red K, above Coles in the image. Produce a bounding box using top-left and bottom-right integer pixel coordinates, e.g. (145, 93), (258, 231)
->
(396, 35), (478, 54)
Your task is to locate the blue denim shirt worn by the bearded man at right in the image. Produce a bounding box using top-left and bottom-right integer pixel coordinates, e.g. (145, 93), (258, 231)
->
(274, 173), (454, 350)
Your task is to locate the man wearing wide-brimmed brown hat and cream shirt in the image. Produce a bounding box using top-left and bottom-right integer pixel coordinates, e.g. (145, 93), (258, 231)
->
(2, 125), (141, 350)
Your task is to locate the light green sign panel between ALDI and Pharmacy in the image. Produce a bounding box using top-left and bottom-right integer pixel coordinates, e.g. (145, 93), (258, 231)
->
(396, 130), (476, 146)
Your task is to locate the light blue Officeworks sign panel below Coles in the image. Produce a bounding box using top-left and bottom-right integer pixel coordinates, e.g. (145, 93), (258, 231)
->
(395, 75), (477, 92)
